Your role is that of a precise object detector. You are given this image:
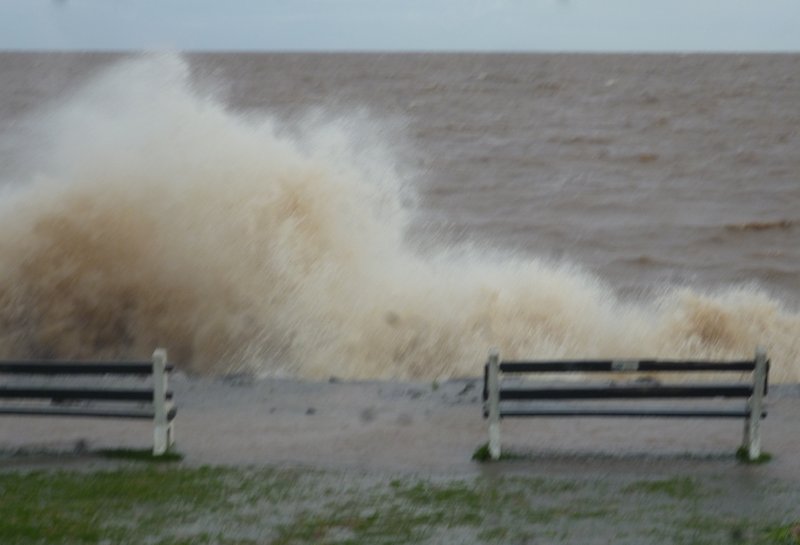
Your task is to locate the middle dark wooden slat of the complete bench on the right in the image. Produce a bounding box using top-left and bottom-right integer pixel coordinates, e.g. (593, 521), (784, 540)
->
(500, 384), (753, 401)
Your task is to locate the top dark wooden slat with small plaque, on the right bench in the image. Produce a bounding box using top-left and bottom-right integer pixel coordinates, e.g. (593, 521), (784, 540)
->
(500, 360), (755, 373)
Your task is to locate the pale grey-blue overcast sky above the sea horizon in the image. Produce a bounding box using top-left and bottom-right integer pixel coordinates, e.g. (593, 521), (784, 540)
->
(0, 0), (800, 51)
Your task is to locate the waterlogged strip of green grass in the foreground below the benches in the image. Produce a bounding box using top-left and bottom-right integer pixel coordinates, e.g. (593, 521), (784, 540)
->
(0, 464), (797, 545)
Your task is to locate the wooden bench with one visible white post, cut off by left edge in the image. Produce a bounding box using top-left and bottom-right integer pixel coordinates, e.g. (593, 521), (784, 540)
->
(0, 348), (177, 456)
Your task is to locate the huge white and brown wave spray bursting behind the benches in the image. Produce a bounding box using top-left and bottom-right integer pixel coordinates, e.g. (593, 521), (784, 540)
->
(0, 56), (800, 382)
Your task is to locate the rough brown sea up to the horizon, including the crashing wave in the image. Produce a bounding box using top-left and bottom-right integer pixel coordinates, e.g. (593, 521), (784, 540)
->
(0, 52), (800, 382)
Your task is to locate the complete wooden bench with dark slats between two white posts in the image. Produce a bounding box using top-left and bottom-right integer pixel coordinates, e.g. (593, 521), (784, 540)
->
(483, 349), (769, 460)
